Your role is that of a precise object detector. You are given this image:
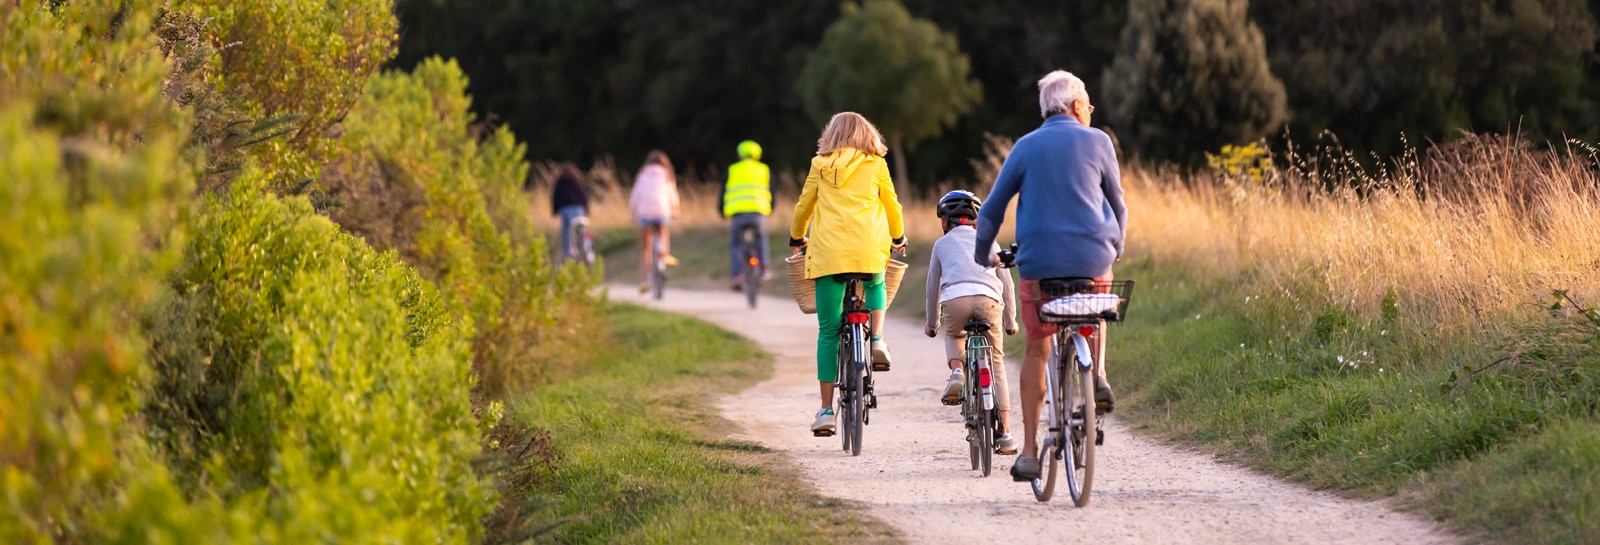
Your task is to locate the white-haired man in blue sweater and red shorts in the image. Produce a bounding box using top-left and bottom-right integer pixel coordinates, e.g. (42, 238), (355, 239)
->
(974, 70), (1128, 481)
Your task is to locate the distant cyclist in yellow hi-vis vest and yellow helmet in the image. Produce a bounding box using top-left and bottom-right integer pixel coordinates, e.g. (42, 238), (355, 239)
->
(722, 141), (774, 291)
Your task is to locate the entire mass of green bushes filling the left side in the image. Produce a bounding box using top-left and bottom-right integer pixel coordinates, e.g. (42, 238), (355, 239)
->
(0, 0), (603, 543)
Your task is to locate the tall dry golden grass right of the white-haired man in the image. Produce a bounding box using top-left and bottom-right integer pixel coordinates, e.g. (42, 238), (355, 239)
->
(1123, 136), (1600, 326)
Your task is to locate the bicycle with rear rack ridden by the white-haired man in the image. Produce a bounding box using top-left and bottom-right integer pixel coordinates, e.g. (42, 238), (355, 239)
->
(1000, 245), (1133, 507)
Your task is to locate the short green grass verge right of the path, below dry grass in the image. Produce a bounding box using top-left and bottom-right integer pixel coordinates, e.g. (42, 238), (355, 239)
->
(1107, 255), (1600, 543)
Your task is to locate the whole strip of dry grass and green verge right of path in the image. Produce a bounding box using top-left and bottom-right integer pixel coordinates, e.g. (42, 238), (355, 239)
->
(1109, 136), (1600, 543)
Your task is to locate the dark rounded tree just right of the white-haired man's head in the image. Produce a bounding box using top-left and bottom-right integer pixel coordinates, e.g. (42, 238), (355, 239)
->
(1101, 0), (1286, 165)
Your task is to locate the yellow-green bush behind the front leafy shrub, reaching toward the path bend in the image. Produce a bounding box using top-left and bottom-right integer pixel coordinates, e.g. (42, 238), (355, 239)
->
(323, 59), (600, 398)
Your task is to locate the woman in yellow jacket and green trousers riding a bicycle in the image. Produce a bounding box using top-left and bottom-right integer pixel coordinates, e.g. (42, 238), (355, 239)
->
(789, 112), (906, 432)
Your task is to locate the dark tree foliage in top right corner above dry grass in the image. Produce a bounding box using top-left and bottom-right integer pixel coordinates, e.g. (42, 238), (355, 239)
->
(1250, 0), (1600, 155)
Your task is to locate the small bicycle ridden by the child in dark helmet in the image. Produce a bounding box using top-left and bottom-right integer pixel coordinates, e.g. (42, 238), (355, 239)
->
(944, 318), (1002, 476)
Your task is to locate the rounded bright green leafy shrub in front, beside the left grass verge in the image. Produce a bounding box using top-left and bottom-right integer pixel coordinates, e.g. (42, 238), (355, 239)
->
(150, 173), (491, 542)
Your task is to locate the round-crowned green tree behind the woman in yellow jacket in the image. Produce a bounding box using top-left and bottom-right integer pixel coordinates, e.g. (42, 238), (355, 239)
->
(795, 0), (982, 181)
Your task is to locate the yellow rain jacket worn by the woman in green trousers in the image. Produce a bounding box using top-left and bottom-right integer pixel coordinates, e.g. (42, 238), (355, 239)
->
(789, 147), (906, 278)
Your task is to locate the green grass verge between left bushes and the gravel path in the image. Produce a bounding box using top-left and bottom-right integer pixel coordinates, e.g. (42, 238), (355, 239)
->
(509, 304), (894, 543)
